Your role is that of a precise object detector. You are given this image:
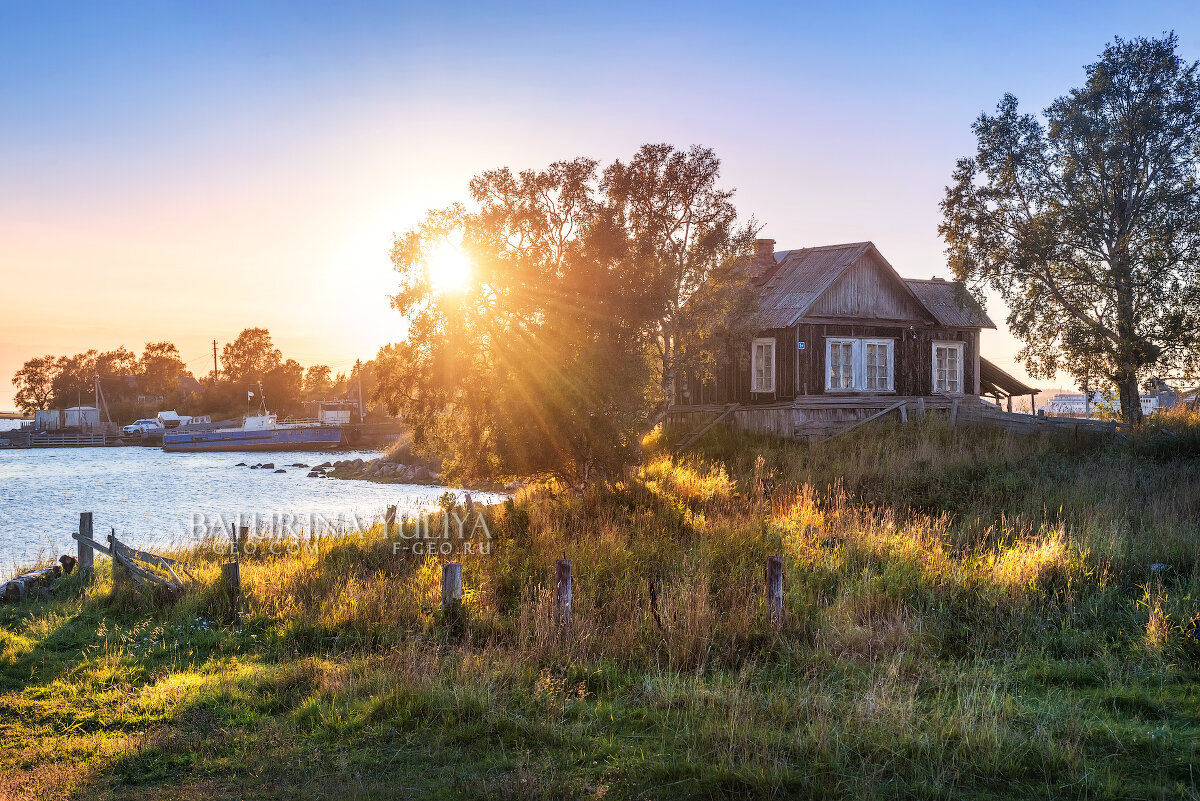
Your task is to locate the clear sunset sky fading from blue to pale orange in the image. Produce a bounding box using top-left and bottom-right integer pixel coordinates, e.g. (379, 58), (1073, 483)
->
(0, 0), (1200, 410)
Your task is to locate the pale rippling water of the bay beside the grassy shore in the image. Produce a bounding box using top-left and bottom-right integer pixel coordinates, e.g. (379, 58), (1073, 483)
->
(0, 443), (499, 577)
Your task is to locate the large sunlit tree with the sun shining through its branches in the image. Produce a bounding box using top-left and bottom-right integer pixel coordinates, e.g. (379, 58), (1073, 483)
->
(376, 145), (750, 486)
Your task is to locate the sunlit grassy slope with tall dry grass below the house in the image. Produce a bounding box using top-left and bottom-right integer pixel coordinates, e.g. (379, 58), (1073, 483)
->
(0, 417), (1200, 799)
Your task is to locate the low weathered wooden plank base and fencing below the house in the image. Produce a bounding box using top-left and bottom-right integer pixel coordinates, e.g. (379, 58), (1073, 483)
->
(666, 395), (1121, 439)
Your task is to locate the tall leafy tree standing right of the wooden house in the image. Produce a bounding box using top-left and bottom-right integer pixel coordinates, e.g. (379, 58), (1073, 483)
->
(938, 34), (1200, 423)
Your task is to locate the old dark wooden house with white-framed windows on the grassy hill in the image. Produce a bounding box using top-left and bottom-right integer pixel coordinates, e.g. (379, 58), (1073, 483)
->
(670, 240), (1037, 436)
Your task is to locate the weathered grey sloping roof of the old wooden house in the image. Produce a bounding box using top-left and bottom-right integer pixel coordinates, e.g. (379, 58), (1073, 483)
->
(754, 242), (996, 329)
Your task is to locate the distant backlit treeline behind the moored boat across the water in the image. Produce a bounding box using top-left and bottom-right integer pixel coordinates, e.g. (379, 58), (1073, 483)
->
(12, 329), (376, 421)
